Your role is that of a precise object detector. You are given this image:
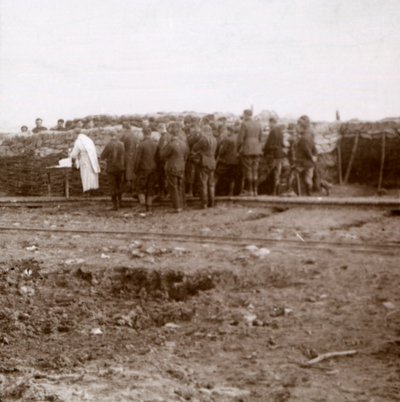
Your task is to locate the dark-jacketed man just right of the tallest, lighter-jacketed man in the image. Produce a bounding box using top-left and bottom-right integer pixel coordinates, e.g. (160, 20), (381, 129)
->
(263, 117), (285, 195)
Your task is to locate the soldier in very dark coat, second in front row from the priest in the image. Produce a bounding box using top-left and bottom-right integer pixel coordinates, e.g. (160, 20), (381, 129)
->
(134, 127), (157, 211)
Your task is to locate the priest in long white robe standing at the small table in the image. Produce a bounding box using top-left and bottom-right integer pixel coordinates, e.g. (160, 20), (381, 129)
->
(70, 128), (100, 192)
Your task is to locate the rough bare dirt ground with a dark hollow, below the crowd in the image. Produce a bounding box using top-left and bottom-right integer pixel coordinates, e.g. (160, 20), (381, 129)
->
(0, 199), (400, 402)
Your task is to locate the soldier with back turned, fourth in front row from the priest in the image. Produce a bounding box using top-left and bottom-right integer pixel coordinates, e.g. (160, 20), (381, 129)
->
(191, 122), (217, 208)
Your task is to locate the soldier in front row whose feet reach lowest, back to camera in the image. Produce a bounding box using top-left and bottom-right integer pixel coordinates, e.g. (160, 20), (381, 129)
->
(160, 123), (189, 213)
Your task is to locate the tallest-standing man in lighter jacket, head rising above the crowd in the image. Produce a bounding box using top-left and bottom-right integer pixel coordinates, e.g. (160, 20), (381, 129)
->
(237, 109), (262, 196)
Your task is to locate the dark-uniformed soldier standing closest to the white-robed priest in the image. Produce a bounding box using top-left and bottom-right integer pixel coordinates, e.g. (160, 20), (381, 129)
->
(100, 133), (125, 211)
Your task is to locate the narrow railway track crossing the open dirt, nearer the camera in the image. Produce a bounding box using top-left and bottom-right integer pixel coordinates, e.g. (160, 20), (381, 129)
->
(0, 226), (400, 255)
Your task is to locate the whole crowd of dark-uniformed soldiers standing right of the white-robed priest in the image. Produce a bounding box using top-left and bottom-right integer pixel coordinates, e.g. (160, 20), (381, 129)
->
(87, 110), (328, 212)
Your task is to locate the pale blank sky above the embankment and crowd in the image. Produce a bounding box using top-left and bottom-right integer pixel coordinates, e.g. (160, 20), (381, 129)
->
(0, 0), (400, 131)
